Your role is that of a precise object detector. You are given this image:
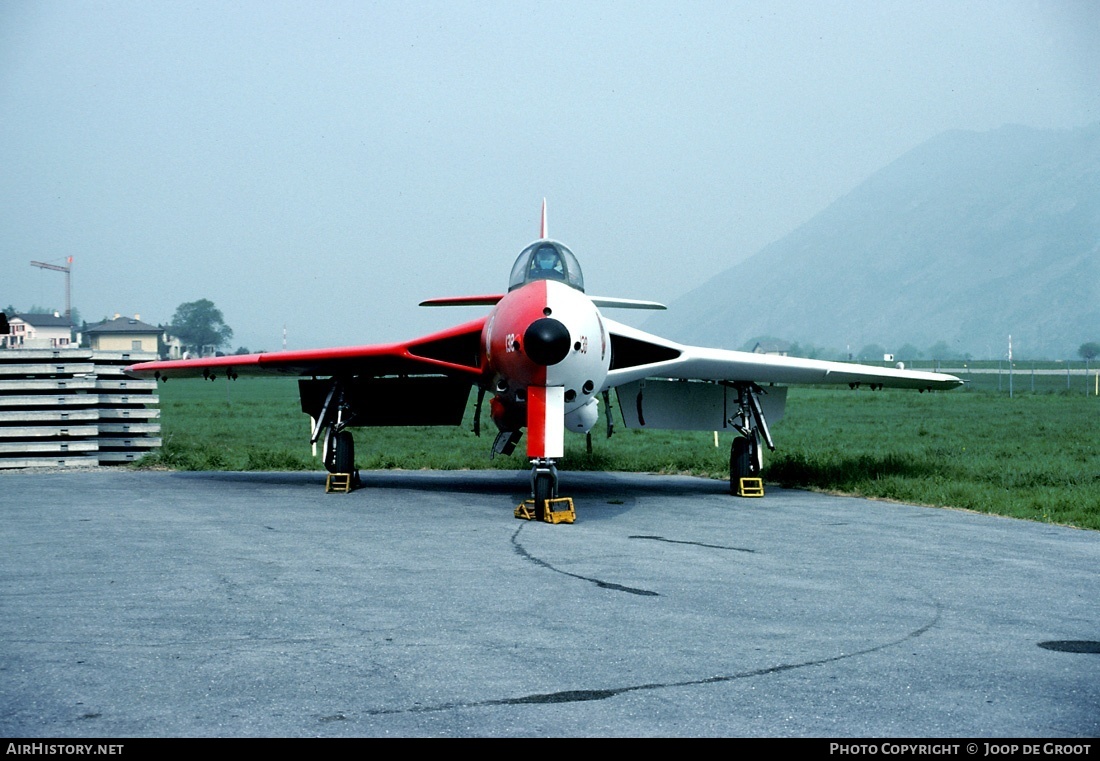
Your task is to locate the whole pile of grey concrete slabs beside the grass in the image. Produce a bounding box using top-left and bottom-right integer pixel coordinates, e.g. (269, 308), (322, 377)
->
(0, 349), (161, 468)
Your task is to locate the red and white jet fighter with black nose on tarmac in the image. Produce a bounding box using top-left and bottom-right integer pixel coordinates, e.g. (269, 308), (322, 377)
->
(127, 200), (963, 519)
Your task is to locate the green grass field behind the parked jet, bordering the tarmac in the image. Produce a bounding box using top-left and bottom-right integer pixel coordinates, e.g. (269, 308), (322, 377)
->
(142, 375), (1100, 530)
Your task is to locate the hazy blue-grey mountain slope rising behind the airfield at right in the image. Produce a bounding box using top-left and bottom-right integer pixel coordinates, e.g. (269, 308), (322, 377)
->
(646, 124), (1100, 357)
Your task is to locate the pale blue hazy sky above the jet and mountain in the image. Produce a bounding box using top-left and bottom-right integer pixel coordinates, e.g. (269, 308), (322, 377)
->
(0, 0), (1100, 350)
